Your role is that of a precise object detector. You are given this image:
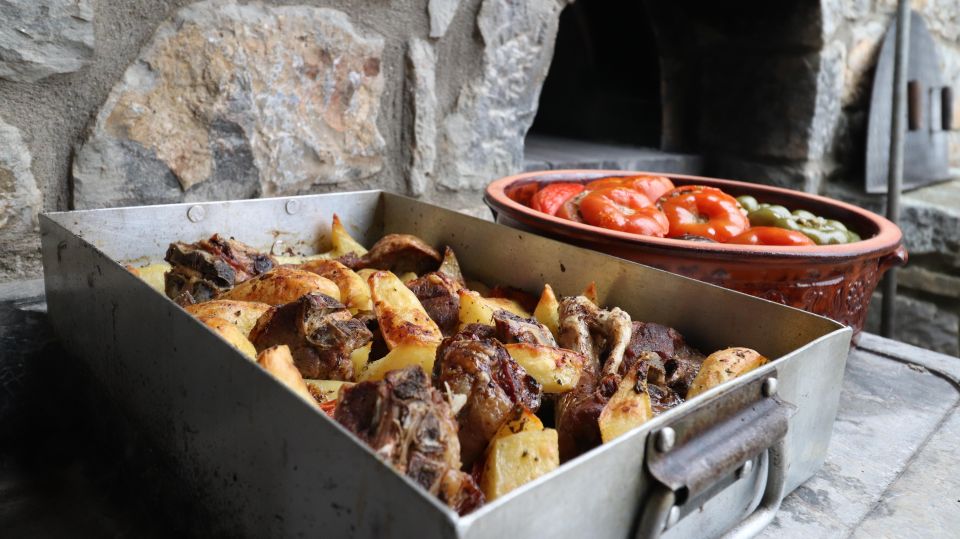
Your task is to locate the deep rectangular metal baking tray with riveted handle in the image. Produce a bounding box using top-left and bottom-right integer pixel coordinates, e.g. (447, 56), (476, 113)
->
(41, 191), (851, 538)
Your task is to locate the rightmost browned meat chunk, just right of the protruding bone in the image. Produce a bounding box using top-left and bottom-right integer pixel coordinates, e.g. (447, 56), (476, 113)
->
(624, 322), (705, 398)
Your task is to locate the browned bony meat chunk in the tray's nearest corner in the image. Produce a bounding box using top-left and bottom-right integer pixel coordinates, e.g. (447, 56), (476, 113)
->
(333, 366), (483, 515)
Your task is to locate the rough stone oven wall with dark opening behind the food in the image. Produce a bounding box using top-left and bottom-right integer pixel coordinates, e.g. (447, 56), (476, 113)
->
(0, 0), (960, 354)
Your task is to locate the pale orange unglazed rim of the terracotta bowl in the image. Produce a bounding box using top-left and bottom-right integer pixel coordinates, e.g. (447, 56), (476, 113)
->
(484, 169), (903, 261)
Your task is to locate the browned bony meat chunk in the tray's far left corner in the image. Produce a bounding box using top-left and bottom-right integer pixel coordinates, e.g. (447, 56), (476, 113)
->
(164, 234), (276, 301)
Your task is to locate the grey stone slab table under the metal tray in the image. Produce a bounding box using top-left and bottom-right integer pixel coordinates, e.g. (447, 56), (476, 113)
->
(0, 281), (960, 539)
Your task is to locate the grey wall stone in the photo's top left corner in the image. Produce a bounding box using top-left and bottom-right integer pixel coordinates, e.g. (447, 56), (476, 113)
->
(0, 0), (95, 82)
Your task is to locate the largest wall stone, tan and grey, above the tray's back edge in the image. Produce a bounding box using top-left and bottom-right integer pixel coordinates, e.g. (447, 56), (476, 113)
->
(73, 1), (385, 208)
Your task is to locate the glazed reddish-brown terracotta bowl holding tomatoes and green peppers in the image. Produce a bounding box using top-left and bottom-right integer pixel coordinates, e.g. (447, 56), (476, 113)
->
(484, 170), (907, 334)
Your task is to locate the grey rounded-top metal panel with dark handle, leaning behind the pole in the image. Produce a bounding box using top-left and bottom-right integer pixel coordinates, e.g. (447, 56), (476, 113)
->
(866, 12), (953, 193)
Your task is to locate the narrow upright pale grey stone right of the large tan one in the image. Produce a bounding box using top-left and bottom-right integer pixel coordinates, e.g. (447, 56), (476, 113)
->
(407, 38), (437, 197)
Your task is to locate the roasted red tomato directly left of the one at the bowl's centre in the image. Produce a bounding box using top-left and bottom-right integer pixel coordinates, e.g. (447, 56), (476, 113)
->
(580, 187), (670, 238)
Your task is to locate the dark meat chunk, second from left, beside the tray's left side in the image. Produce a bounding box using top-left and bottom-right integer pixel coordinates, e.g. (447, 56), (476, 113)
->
(250, 294), (373, 380)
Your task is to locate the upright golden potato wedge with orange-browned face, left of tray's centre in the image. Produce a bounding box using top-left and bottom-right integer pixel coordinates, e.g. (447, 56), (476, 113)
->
(368, 271), (443, 350)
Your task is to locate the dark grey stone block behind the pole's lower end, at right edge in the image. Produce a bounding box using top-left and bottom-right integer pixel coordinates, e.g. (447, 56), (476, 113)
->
(864, 289), (960, 356)
